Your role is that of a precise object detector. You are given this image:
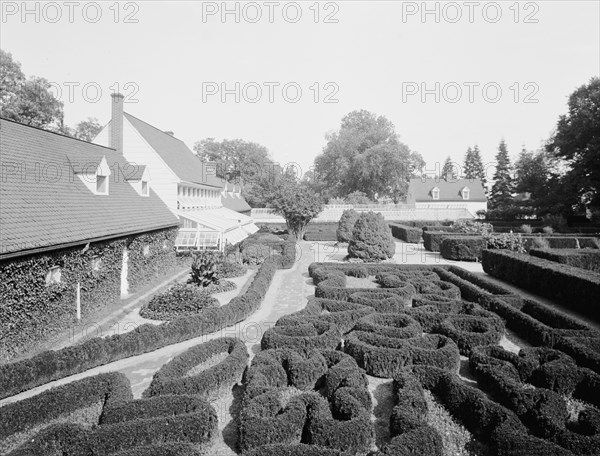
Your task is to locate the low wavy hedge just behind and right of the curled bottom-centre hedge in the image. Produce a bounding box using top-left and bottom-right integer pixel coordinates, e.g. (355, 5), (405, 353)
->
(344, 331), (460, 378)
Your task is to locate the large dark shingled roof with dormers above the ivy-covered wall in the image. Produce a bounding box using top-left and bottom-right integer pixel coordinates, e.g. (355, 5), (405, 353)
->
(0, 119), (179, 259)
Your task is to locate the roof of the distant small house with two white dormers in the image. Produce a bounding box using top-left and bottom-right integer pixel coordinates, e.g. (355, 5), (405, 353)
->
(407, 178), (487, 203)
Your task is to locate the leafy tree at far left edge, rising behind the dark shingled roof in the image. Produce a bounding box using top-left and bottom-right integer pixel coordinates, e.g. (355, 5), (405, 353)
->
(0, 50), (65, 132)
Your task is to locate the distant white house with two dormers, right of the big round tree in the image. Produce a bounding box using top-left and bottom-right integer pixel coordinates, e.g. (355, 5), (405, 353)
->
(406, 176), (487, 216)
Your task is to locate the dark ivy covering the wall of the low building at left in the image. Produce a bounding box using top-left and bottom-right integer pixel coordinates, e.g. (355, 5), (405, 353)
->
(0, 228), (177, 361)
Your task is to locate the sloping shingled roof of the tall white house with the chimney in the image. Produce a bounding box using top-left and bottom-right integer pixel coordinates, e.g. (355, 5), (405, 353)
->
(123, 113), (225, 189)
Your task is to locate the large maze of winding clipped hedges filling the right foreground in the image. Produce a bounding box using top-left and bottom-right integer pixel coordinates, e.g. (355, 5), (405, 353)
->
(240, 263), (600, 456)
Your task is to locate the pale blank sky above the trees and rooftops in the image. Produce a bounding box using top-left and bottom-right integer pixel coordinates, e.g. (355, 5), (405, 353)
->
(0, 0), (600, 179)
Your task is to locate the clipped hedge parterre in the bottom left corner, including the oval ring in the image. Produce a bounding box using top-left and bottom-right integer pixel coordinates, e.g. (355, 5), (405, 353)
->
(0, 338), (248, 456)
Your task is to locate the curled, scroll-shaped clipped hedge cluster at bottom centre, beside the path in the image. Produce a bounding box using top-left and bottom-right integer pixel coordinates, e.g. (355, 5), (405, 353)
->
(240, 350), (373, 454)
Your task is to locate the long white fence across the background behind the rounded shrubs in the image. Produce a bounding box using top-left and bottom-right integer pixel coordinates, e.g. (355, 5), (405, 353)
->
(252, 204), (473, 223)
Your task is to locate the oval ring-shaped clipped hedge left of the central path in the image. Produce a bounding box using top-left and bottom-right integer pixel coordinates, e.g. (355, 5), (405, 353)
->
(144, 337), (248, 399)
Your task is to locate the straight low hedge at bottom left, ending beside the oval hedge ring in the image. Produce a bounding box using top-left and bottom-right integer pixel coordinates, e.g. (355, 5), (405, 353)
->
(0, 372), (133, 447)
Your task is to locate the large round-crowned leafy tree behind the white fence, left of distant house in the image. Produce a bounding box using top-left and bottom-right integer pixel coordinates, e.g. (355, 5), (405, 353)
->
(315, 110), (424, 201)
